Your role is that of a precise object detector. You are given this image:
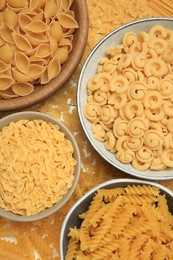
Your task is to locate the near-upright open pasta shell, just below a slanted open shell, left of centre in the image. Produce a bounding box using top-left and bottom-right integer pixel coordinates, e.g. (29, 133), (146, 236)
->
(14, 51), (30, 74)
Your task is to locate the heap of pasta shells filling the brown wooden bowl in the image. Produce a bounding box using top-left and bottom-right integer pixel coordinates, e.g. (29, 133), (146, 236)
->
(0, 0), (78, 99)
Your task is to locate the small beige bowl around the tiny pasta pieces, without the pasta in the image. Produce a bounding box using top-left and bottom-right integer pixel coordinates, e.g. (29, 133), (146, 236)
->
(0, 111), (81, 222)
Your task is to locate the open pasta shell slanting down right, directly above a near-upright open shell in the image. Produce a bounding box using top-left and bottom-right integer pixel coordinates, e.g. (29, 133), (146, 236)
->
(12, 33), (32, 51)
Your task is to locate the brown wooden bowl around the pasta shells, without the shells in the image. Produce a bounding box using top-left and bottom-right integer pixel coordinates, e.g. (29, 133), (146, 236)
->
(0, 0), (88, 111)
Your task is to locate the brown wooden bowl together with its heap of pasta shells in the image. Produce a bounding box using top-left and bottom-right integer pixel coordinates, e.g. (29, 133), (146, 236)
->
(0, 0), (88, 111)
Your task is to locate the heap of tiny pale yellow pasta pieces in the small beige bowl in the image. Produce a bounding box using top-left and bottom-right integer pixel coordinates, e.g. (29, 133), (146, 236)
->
(0, 120), (76, 216)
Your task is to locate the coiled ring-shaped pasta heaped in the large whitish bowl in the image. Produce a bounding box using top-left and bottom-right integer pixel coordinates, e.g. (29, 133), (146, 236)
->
(84, 25), (173, 170)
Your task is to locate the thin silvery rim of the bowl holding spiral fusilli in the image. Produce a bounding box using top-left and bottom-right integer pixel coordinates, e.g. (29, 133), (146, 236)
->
(59, 178), (173, 260)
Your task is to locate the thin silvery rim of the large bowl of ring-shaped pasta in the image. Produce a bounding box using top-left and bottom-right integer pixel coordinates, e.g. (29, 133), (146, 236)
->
(77, 17), (173, 180)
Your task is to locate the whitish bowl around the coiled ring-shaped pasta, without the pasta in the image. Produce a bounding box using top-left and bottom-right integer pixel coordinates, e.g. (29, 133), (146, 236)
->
(77, 18), (173, 180)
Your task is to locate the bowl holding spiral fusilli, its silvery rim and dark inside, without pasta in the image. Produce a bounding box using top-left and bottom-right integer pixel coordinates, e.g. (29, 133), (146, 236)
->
(60, 179), (173, 260)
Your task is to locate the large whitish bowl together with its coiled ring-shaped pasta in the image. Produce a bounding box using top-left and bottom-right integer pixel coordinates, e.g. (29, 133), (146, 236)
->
(77, 18), (173, 180)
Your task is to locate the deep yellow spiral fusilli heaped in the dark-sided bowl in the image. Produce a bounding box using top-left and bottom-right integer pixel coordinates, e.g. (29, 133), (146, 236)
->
(65, 185), (173, 260)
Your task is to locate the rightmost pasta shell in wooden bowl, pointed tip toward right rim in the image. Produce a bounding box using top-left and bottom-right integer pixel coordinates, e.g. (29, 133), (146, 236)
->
(57, 12), (79, 29)
